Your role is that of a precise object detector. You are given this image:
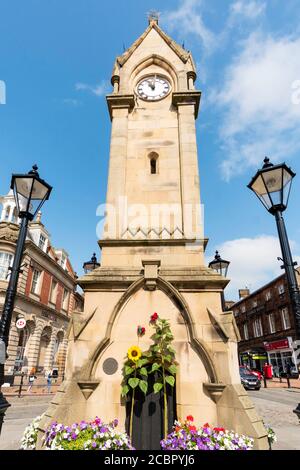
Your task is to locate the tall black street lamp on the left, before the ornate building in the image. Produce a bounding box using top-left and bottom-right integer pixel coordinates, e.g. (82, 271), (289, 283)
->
(0, 165), (52, 433)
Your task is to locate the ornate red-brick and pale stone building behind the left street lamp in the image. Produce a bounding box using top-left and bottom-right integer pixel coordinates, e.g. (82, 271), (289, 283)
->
(0, 191), (83, 376)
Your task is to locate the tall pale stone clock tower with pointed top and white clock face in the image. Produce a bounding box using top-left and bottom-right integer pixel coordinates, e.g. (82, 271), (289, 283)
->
(41, 18), (267, 448)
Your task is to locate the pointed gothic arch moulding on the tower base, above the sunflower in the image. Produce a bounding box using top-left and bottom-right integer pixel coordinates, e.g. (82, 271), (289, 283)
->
(85, 277), (218, 383)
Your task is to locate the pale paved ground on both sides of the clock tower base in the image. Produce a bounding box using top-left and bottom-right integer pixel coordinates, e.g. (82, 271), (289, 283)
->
(0, 388), (300, 450)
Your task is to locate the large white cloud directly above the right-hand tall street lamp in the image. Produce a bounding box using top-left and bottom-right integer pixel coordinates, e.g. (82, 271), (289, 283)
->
(210, 33), (300, 180)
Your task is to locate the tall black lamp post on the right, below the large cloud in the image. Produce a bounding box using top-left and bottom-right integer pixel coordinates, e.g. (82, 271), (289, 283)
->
(248, 157), (300, 417)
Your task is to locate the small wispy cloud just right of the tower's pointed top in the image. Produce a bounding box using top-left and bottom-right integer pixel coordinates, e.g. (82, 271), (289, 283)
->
(162, 0), (216, 52)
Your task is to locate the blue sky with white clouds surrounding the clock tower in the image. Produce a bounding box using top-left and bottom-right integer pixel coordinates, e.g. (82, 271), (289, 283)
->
(0, 0), (300, 298)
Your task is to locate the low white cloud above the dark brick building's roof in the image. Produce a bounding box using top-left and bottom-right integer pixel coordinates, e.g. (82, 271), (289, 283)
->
(208, 235), (299, 300)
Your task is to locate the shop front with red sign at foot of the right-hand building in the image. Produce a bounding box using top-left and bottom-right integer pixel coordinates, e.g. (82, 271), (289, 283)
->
(264, 336), (297, 377)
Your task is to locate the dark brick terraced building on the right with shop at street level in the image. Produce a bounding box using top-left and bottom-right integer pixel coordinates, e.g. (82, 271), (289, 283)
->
(231, 270), (300, 372)
